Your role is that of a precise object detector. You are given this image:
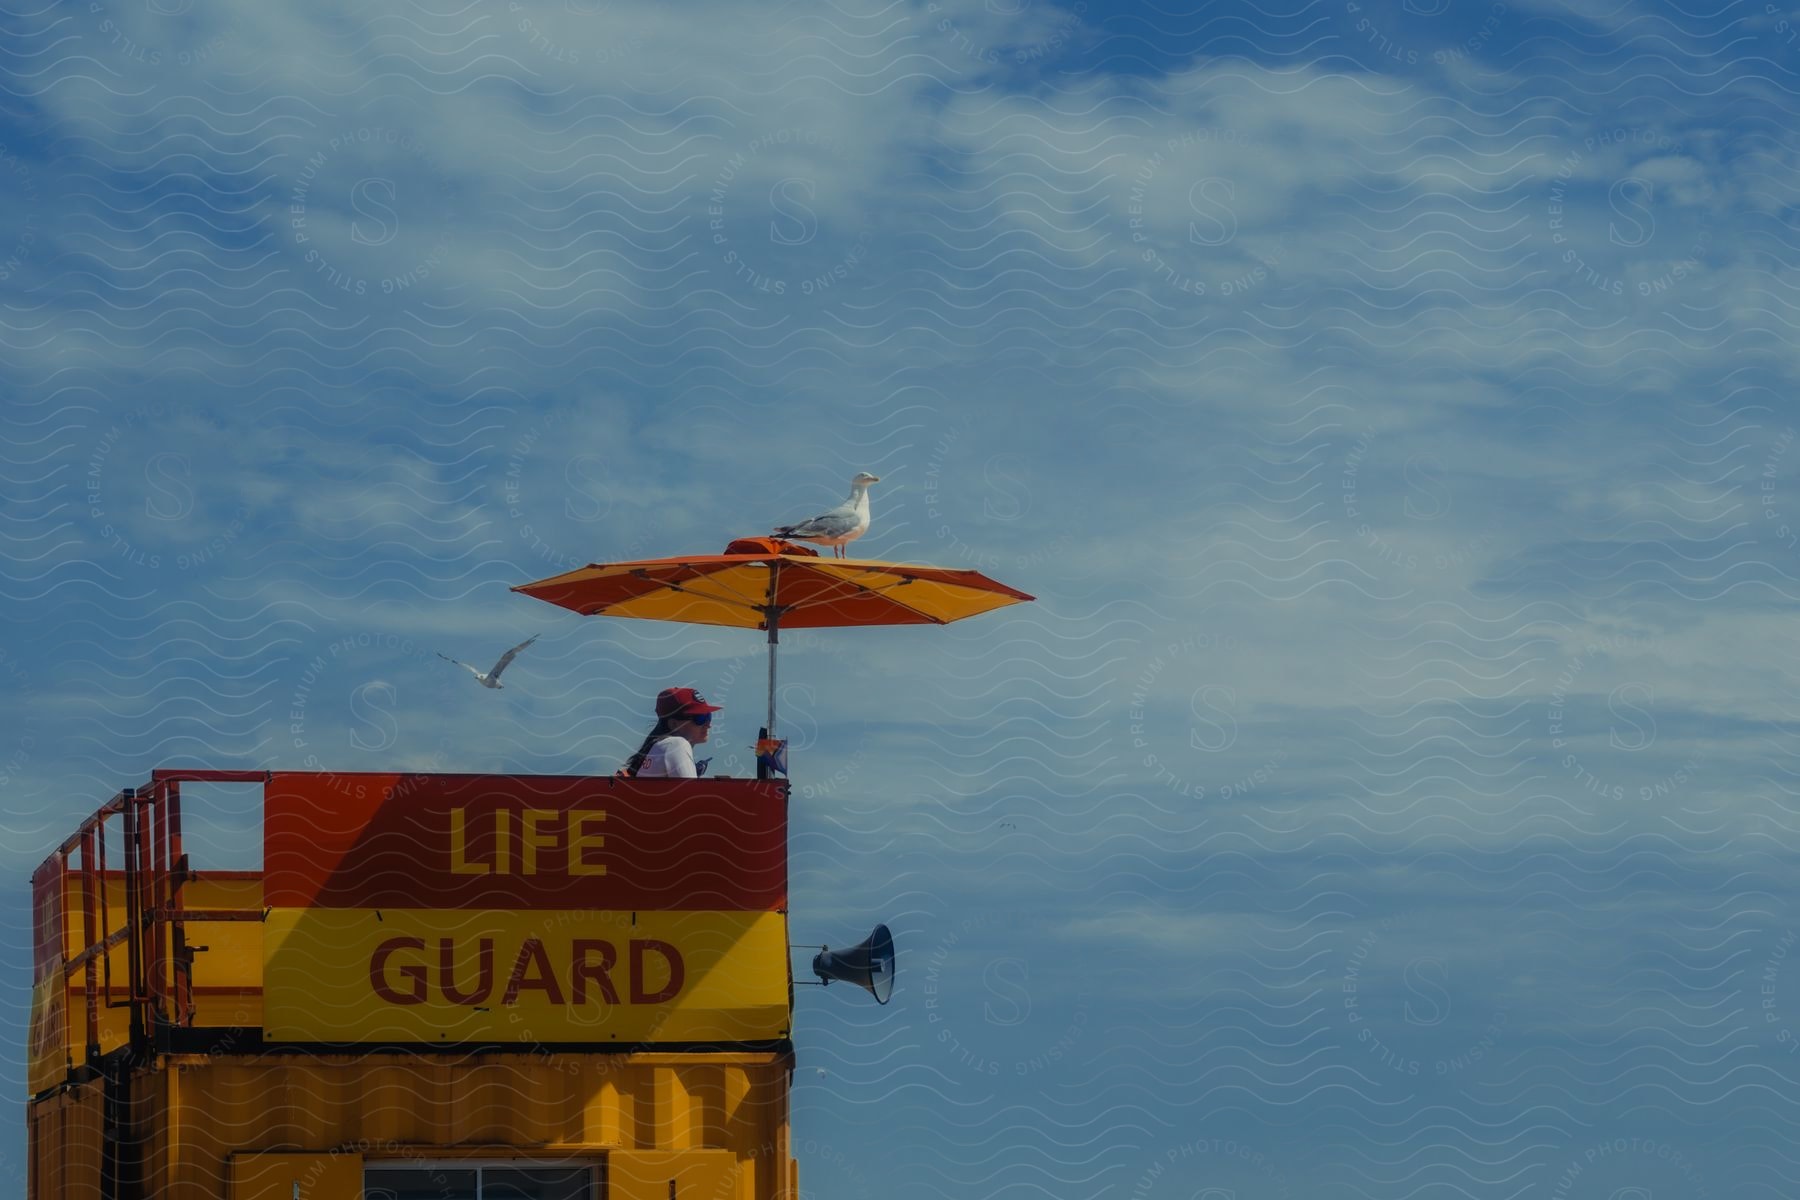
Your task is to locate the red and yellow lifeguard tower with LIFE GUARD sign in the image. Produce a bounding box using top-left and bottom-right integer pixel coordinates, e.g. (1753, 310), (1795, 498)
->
(29, 770), (797, 1200)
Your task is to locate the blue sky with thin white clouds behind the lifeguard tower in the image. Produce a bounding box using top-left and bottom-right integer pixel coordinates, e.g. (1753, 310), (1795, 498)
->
(0, 0), (1800, 1200)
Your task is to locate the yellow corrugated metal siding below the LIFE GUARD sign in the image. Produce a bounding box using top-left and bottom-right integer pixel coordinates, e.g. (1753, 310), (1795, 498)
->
(45, 1054), (790, 1200)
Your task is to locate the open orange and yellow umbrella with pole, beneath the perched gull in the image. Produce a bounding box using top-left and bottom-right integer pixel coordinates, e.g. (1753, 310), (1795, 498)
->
(513, 543), (1035, 752)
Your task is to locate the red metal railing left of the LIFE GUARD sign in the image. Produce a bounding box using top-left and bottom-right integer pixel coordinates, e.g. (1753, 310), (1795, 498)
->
(34, 770), (268, 1056)
